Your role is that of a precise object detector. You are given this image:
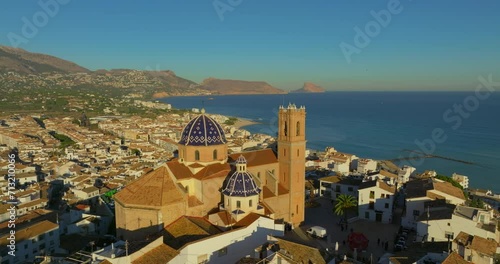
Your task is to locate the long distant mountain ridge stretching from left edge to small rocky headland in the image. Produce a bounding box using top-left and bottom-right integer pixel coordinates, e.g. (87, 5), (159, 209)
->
(0, 46), (314, 98)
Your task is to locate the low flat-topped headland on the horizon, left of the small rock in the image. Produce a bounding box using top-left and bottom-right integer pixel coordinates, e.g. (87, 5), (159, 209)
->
(200, 78), (286, 94)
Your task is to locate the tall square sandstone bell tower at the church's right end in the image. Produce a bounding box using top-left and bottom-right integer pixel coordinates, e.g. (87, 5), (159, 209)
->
(277, 104), (306, 227)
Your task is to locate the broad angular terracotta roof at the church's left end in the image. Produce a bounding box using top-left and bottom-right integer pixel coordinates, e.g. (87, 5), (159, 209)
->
(114, 166), (184, 206)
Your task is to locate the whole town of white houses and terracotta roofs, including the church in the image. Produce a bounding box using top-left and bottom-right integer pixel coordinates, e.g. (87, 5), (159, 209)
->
(0, 104), (500, 264)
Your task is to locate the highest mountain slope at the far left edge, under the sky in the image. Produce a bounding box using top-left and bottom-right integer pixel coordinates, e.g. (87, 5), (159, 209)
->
(0, 46), (89, 74)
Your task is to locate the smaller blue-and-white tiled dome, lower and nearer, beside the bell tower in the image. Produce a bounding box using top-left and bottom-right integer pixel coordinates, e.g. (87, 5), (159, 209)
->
(222, 171), (260, 197)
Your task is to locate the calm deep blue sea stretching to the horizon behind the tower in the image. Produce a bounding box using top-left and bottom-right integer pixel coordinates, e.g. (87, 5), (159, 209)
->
(162, 92), (500, 192)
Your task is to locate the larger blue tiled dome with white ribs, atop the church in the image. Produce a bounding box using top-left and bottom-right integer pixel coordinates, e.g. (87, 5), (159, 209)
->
(179, 113), (227, 146)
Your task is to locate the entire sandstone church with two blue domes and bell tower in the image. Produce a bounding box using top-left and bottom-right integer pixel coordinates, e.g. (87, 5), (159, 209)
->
(114, 104), (306, 240)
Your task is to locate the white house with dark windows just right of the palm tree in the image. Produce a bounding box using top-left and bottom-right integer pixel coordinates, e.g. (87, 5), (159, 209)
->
(358, 180), (396, 223)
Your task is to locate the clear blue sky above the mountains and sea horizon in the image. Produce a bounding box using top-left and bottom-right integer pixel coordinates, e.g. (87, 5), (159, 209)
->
(0, 0), (500, 90)
